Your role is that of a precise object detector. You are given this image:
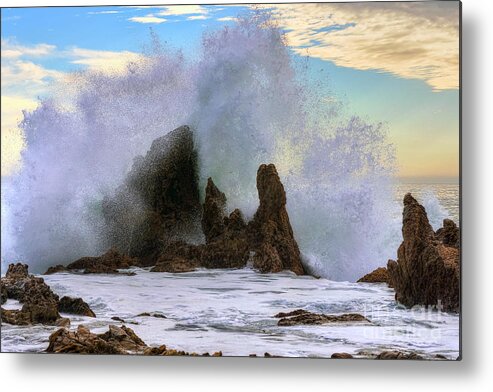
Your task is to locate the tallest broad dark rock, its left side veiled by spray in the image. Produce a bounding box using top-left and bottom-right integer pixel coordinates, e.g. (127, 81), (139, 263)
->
(103, 126), (201, 265)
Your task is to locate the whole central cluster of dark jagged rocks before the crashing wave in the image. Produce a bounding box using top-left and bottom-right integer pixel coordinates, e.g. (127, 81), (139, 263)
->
(41, 126), (305, 275)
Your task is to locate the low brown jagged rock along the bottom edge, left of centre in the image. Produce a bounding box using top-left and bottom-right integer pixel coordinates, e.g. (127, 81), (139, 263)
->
(46, 325), (222, 357)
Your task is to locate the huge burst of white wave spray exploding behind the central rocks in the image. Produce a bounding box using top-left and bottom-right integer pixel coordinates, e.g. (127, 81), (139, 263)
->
(2, 12), (422, 280)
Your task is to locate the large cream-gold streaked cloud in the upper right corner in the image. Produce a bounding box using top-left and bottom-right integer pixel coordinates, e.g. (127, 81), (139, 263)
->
(262, 2), (459, 90)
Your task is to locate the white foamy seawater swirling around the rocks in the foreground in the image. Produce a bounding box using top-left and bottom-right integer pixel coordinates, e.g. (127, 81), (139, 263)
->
(2, 268), (459, 359)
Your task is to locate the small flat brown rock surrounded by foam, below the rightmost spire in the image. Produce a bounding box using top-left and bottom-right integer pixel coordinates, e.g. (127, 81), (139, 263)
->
(274, 309), (370, 327)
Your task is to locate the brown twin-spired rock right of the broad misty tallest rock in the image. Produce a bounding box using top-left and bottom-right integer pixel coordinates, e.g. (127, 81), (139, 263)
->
(153, 164), (304, 275)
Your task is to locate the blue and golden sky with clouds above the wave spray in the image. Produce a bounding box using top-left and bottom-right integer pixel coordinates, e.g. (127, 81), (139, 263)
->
(1, 2), (459, 177)
